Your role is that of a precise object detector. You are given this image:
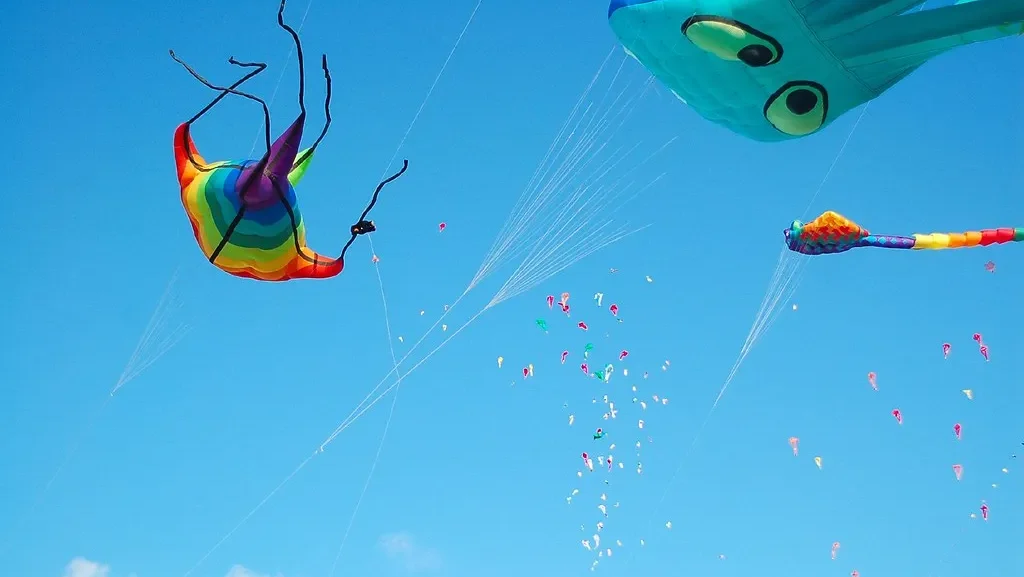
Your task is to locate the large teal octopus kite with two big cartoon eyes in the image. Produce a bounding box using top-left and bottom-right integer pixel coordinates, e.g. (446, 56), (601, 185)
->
(608, 0), (1024, 141)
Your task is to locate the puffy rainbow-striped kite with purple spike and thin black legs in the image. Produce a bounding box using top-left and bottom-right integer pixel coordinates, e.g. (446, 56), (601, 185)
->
(171, 0), (409, 281)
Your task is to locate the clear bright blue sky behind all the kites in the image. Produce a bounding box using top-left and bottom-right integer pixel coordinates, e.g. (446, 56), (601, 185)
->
(0, 0), (1024, 577)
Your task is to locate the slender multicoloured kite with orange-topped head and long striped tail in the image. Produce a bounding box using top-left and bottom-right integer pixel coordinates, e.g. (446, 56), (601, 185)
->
(782, 210), (1024, 254)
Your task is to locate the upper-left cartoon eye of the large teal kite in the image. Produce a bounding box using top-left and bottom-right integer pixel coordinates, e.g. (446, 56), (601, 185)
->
(682, 15), (782, 68)
